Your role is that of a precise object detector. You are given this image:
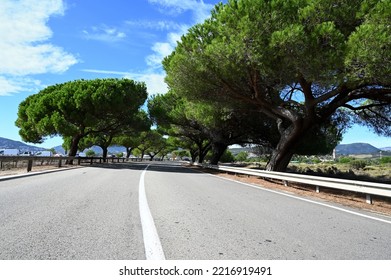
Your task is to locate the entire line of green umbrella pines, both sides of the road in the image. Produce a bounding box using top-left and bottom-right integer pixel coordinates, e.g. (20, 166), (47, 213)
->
(16, 0), (391, 171)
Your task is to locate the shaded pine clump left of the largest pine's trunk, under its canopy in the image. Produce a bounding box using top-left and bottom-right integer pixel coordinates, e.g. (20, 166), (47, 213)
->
(148, 91), (284, 164)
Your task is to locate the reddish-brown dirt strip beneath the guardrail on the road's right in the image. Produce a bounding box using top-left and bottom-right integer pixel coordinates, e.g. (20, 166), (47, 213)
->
(191, 167), (391, 217)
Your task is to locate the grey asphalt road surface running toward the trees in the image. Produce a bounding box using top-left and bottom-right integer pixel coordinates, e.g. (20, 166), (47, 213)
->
(0, 163), (391, 260)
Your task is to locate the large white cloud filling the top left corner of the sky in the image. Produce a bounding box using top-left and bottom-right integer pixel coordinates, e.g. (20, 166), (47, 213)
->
(0, 0), (77, 95)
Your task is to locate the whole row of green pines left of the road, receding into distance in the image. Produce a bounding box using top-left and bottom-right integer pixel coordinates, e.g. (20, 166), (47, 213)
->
(16, 79), (181, 160)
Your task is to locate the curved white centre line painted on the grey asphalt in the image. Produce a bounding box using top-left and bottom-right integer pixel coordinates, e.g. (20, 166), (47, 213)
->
(138, 165), (166, 260)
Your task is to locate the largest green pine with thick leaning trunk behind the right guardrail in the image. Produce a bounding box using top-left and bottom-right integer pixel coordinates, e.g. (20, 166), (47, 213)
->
(163, 0), (391, 171)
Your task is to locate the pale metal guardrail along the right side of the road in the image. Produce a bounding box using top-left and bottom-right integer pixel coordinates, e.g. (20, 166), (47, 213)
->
(203, 165), (391, 204)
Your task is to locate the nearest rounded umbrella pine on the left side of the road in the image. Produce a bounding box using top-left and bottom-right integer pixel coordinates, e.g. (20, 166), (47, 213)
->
(16, 79), (147, 156)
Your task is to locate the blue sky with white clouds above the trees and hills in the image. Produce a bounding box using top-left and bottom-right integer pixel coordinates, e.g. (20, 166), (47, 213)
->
(0, 0), (391, 148)
